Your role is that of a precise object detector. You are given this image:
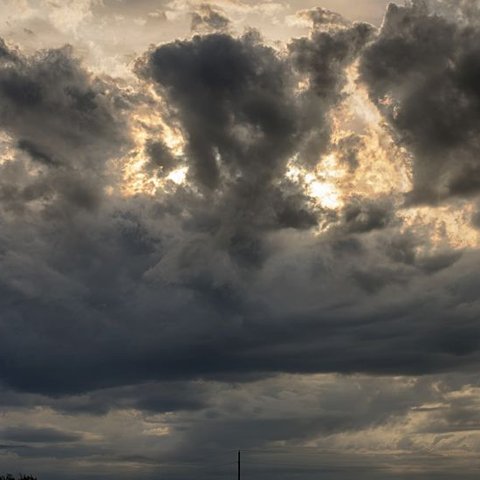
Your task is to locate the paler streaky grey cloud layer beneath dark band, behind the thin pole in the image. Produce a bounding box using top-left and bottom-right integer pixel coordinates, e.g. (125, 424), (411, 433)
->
(6, 374), (478, 478)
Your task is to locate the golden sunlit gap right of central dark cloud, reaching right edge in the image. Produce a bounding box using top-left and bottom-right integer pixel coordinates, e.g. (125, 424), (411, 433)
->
(287, 67), (480, 250)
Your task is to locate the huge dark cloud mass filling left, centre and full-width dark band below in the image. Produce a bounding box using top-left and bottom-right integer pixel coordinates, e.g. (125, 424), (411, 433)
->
(0, 2), (479, 420)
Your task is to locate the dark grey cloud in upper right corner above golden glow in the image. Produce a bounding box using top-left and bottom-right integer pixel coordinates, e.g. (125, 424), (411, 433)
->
(361, 1), (480, 203)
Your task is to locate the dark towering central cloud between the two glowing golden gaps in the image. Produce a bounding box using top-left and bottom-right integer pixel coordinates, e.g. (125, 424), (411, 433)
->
(133, 25), (371, 274)
